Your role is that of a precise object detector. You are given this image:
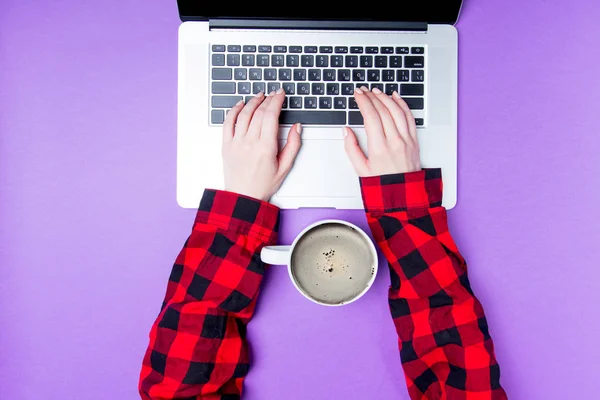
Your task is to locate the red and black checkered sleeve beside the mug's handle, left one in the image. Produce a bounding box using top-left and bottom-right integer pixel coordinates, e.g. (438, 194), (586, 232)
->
(139, 190), (279, 400)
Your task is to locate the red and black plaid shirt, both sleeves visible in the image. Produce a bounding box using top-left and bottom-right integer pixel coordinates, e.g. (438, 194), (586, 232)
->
(139, 170), (507, 400)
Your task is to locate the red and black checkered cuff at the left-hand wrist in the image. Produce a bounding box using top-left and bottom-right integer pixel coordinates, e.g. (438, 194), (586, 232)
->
(196, 189), (279, 245)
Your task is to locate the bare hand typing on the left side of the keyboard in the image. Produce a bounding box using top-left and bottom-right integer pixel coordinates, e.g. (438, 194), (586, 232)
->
(223, 89), (302, 201)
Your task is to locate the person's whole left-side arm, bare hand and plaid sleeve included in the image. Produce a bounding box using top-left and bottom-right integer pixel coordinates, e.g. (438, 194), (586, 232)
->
(139, 91), (301, 400)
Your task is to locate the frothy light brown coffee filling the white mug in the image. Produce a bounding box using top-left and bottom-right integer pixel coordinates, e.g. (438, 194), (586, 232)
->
(291, 223), (376, 304)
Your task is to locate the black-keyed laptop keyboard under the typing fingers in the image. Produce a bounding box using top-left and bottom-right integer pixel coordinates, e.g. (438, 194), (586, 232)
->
(210, 44), (426, 126)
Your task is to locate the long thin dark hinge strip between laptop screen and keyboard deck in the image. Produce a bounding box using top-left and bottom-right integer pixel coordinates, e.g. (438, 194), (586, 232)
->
(209, 18), (427, 31)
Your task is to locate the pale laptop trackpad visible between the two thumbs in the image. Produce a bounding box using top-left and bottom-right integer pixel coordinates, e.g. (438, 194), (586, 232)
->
(277, 140), (360, 197)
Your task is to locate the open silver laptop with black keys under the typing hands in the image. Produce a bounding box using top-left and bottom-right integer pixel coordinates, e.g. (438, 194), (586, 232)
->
(177, 0), (462, 209)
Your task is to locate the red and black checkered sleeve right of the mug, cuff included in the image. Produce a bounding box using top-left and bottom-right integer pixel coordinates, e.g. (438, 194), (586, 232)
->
(361, 169), (506, 400)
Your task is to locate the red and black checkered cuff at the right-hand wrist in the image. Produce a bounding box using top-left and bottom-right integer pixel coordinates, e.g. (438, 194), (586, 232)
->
(360, 168), (442, 213)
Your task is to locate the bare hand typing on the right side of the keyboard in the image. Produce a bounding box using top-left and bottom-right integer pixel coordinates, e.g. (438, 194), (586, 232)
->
(344, 86), (421, 176)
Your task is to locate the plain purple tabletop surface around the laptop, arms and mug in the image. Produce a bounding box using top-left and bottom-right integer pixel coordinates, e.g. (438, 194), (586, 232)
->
(0, 0), (600, 400)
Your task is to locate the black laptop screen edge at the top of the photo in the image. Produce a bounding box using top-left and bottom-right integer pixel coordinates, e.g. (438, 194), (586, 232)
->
(177, 0), (462, 24)
